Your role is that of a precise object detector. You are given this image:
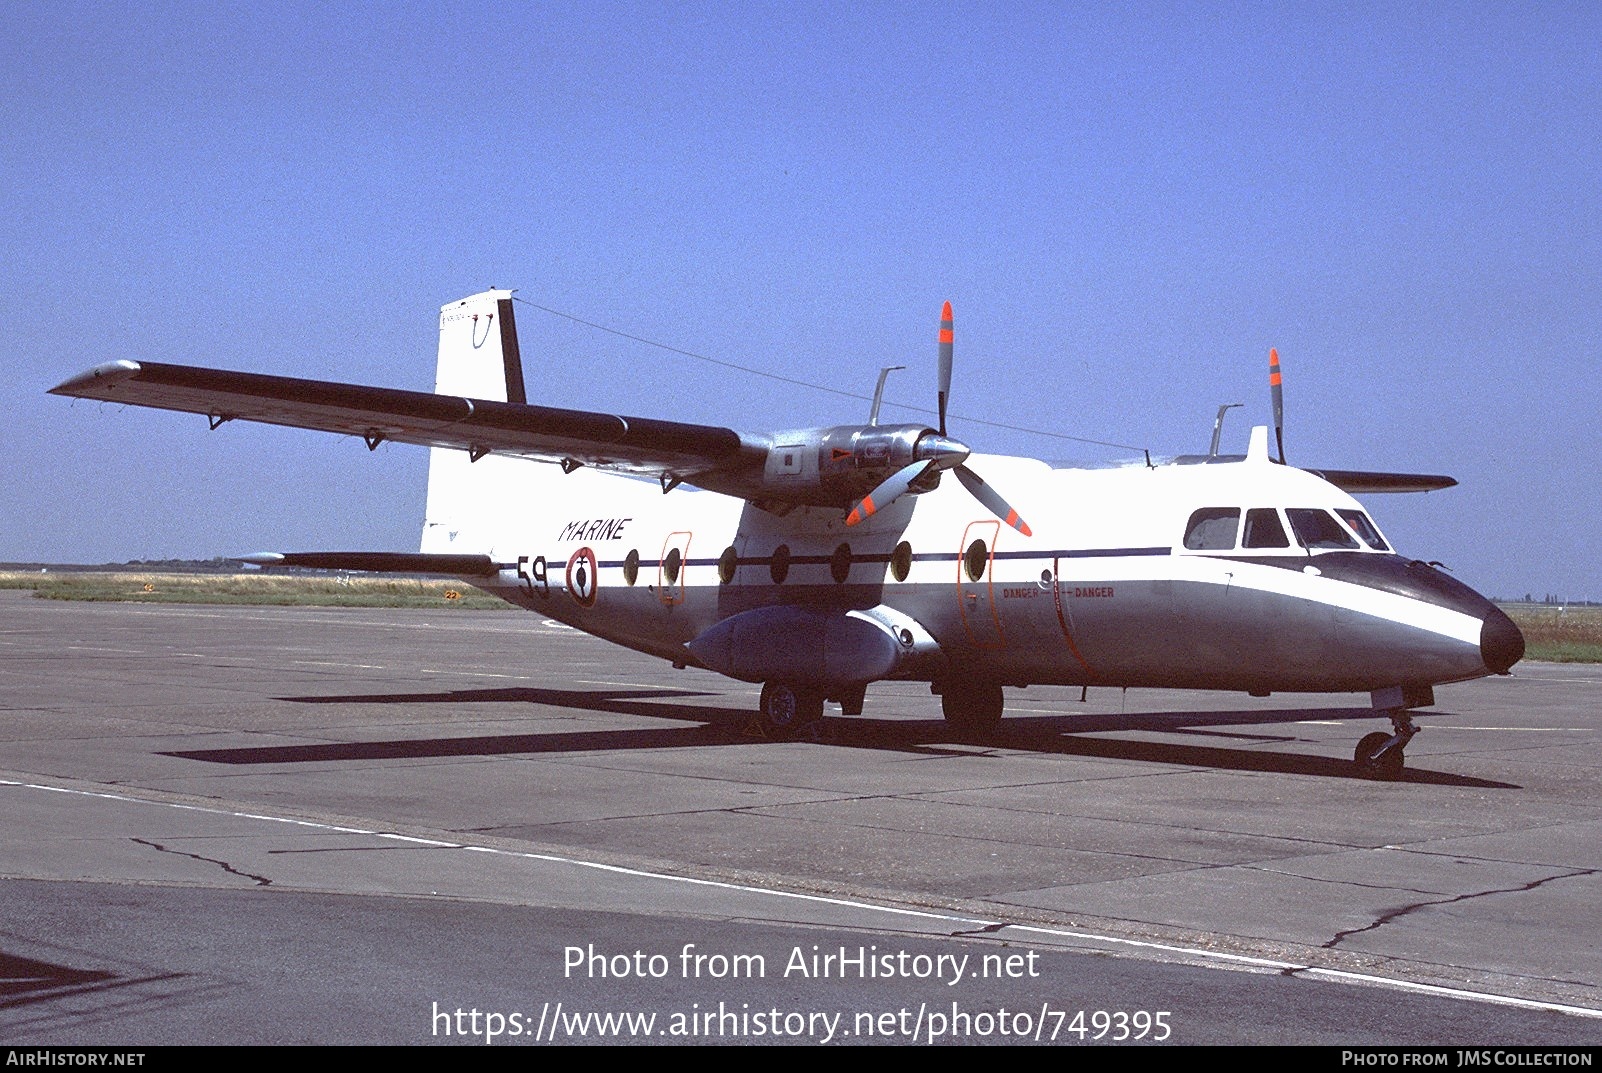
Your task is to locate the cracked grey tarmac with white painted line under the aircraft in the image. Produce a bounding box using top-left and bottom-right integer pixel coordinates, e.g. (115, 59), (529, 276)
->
(0, 591), (1602, 1044)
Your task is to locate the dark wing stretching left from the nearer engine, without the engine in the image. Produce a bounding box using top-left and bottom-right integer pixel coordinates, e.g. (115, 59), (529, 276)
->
(50, 360), (766, 487)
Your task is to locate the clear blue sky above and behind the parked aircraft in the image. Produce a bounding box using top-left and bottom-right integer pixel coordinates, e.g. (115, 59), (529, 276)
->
(0, 2), (1602, 599)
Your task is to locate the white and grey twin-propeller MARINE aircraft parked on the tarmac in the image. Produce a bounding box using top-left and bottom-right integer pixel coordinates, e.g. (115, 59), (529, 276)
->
(53, 290), (1524, 778)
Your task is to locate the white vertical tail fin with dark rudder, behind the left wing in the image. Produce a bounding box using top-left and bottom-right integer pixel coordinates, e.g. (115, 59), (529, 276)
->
(423, 290), (529, 554)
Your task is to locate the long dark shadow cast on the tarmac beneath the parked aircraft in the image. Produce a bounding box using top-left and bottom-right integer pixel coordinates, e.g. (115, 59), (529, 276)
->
(162, 687), (1517, 790)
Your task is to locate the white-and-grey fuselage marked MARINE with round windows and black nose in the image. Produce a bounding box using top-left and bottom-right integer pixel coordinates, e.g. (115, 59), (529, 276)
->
(425, 442), (1522, 693)
